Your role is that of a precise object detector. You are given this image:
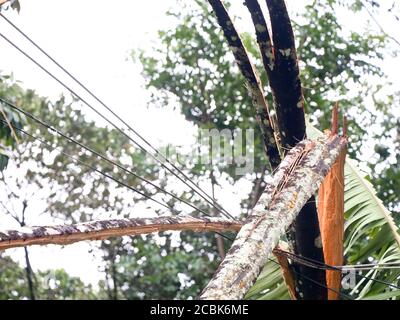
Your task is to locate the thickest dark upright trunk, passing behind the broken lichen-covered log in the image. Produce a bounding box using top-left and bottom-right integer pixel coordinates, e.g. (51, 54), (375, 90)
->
(245, 0), (327, 299)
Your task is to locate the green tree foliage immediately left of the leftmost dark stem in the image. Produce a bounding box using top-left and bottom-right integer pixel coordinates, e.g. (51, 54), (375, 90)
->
(138, 0), (266, 185)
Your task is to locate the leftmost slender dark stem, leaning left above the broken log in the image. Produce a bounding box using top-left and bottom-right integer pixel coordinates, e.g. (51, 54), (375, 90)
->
(208, 0), (281, 169)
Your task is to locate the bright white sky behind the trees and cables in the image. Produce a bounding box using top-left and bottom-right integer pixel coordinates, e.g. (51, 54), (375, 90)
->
(0, 0), (400, 283)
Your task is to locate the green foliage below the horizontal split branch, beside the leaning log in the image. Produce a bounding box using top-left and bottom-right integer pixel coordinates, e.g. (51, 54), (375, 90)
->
(102, 233), (219, 299)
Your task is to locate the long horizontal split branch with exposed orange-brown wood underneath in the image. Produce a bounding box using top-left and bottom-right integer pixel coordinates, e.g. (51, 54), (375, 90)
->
(0, 216), (242, 250)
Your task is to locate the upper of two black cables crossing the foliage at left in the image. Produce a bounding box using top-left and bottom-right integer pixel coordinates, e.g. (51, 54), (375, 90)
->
(0, 97), (222, 217)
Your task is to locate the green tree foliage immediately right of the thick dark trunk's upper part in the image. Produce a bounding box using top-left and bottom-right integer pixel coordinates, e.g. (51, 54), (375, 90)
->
(294, 1), (387, 158)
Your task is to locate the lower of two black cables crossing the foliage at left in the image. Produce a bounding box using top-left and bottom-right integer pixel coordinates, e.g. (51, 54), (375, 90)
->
(0, 119), (233, 241)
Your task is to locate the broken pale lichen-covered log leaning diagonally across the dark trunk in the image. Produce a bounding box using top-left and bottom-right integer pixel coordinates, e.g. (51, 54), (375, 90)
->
(200, 136), (346, 299)
